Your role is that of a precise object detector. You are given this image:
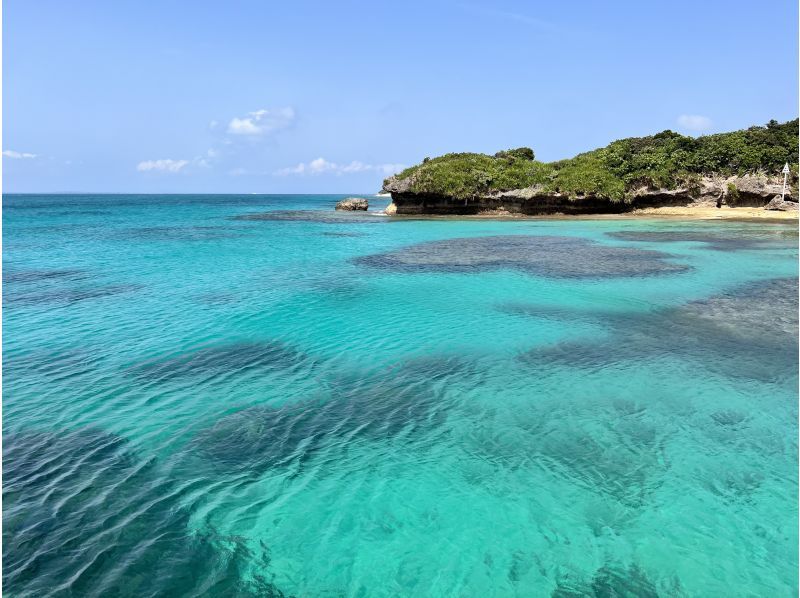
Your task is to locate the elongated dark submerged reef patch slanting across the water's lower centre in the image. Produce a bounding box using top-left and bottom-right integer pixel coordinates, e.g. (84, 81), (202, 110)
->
(192, 356), (474, 475)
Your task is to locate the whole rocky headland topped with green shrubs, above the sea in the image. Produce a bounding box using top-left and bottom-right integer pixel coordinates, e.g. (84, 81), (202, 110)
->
(382, 119), (798, 216)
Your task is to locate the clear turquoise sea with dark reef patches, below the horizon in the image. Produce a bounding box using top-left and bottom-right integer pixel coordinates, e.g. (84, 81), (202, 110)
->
(3, 195), (798, 597)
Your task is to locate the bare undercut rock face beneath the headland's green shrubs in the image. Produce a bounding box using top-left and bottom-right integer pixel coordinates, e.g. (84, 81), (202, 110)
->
(383, 175), (797, 216)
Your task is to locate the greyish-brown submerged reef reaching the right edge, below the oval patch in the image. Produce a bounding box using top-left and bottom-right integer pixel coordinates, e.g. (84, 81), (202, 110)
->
(516, 278), (798, 380)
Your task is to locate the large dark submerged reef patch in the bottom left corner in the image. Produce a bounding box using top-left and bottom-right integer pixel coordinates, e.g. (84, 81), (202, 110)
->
(2, 428), (285, 598)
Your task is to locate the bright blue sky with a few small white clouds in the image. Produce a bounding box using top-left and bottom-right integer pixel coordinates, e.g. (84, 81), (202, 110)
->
(2, 0), (798, 193)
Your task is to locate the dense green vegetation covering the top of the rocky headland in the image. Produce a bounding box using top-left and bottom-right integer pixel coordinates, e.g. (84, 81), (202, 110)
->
(385, 119), (798, 201)
